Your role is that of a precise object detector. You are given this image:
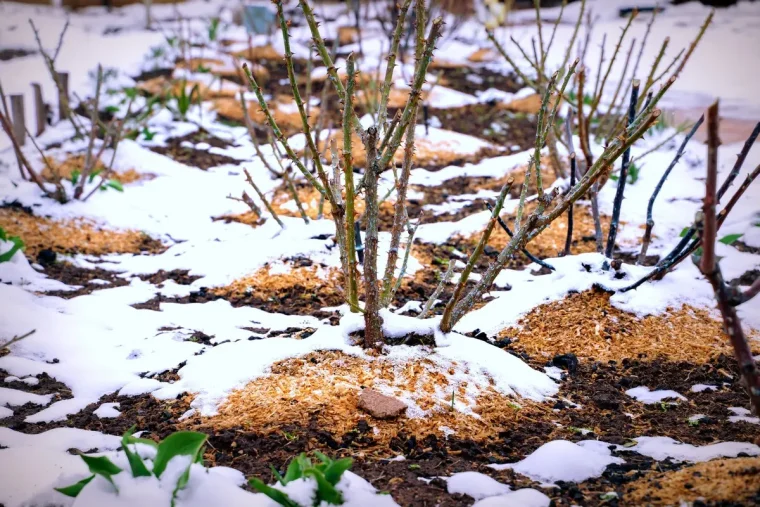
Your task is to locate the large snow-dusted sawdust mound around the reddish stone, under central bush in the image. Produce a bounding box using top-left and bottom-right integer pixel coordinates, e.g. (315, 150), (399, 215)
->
(189, 350), (549, 445)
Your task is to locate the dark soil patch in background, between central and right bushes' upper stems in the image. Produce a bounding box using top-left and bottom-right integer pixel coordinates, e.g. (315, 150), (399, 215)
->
(430, 104), (536, 149)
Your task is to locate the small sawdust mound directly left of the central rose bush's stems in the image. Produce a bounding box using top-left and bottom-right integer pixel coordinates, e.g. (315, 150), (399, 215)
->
(209, 259), (345, 315)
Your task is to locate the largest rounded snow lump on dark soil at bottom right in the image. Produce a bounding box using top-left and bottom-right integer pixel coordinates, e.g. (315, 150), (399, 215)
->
(489, 440), (624, 482)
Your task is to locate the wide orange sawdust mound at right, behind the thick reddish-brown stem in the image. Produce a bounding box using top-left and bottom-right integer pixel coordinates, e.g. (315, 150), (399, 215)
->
(499, 289), (730, 363)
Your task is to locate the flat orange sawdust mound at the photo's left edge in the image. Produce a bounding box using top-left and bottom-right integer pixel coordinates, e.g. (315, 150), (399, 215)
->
(0, 207), (165, 262)
